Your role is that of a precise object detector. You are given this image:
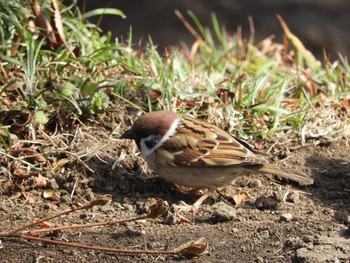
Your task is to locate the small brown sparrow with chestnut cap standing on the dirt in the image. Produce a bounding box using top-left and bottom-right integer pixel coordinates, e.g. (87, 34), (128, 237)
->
(121, 111), (313, 210)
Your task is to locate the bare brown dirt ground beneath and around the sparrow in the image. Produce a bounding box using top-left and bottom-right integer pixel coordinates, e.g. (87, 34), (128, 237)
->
(0, 108), (350, 262)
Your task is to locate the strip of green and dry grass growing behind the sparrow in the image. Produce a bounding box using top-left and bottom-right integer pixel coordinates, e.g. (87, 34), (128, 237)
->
(0, 0), (350, 142)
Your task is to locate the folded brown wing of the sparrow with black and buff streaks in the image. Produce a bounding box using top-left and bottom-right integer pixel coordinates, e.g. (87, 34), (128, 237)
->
(162, 117), (267, 167)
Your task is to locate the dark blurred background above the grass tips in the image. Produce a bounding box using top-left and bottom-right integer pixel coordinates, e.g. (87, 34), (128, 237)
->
(65, 0), (350, 60)
